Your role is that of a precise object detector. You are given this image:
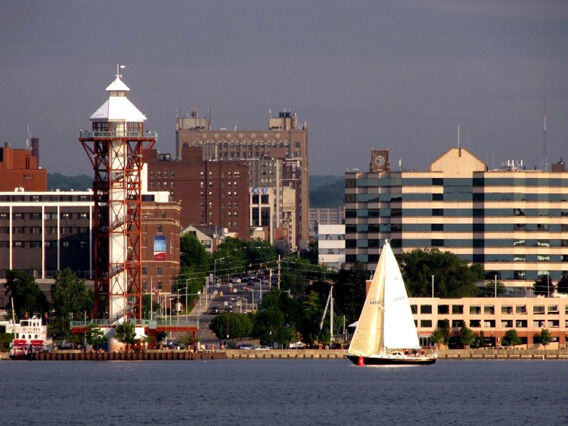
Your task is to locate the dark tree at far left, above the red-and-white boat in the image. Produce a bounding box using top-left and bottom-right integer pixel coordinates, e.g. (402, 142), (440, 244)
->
(4, 270), (49, 318)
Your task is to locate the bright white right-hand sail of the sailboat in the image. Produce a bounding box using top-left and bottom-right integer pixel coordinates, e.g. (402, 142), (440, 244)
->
(381, 243), (420, 350)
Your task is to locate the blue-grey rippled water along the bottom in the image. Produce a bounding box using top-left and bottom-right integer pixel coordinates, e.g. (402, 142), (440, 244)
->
(0, 360), (568, 425)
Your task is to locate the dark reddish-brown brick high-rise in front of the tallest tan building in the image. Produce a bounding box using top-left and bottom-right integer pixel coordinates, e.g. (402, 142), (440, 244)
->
(147, 147), (249, 240)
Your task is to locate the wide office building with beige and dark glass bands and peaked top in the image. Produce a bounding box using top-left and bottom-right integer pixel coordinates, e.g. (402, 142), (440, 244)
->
(345, 148), (568, 287)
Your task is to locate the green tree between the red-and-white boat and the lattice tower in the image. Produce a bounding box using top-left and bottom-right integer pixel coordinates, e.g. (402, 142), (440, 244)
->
(50, 268), (93, 338)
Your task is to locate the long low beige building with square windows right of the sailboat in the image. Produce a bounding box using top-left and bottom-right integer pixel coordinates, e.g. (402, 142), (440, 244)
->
(410, 297), (568, 347)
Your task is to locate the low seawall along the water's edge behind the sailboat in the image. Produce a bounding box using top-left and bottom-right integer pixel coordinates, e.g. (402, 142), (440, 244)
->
(0, 349), (568, 361)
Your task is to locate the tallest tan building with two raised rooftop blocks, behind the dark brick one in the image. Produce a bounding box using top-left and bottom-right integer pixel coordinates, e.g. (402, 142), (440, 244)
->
(176, 111), (310, 250)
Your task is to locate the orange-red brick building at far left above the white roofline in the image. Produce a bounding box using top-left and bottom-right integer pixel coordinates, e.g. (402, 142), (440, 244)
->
(0, 138), (47, 191)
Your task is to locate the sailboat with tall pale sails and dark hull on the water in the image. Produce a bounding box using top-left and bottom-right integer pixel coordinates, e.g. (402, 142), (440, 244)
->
(347, 241), (437, 366)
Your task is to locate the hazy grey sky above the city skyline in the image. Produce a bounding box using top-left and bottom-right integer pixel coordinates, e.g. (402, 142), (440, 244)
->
(0, 0), (568, 176)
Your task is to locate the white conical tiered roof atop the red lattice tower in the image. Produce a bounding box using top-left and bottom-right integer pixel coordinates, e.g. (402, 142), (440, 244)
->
(89, 75), (147, 123)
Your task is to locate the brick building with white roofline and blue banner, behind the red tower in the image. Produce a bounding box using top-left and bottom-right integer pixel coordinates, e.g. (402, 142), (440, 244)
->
(0, 191), (181, 293)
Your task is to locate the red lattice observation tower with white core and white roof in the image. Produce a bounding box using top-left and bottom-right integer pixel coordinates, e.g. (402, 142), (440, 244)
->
(79, 65), (158, 326)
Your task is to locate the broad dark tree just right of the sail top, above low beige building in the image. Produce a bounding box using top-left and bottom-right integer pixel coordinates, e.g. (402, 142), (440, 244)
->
(401, 249), (484, 297)
